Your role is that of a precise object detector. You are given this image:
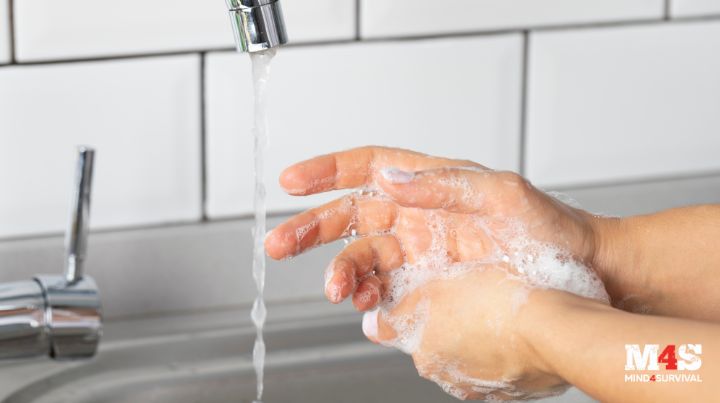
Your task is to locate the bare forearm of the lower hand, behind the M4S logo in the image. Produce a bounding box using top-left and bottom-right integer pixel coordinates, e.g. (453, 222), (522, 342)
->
(521, 291), (720, 402)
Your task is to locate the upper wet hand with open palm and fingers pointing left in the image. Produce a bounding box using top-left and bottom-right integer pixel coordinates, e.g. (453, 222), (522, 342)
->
(265, 147), (596, 311)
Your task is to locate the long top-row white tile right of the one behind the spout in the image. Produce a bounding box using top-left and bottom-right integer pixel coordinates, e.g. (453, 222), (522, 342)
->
(360, 0), (664, 38)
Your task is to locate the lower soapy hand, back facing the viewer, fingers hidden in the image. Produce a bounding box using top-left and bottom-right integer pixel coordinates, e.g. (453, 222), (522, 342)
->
(363, 265), (580, 400)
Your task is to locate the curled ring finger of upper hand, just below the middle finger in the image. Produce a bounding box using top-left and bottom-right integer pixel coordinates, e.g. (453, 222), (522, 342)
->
(325, 235), (404, 304)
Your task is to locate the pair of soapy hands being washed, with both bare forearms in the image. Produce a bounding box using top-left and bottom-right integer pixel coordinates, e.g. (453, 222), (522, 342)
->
(265, 147), (720, 402)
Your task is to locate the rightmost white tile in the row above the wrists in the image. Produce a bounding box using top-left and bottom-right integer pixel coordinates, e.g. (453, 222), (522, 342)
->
(527, 22), (720, 185)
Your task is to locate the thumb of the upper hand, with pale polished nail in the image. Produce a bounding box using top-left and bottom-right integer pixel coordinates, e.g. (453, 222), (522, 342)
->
(378, 168), (529, 213)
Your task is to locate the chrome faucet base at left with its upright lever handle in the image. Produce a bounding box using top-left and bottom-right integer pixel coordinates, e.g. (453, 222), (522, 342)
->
(0, 147), (102, 360)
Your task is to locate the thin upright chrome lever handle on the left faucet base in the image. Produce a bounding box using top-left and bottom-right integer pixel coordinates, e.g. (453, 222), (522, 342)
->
(65, 146), (95, 283)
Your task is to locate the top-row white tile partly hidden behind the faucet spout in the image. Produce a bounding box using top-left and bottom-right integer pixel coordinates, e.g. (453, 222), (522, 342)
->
(15, 0), (355, 61)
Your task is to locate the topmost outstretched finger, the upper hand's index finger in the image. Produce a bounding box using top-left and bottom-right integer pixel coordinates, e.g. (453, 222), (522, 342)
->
(280, 147), (479, 196)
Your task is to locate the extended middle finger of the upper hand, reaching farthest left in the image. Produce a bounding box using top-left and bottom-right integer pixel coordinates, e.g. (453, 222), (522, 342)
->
(265, 194), (397, 259)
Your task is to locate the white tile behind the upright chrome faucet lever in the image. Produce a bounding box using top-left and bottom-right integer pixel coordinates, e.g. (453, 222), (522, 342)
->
(0, 56), (200, 237)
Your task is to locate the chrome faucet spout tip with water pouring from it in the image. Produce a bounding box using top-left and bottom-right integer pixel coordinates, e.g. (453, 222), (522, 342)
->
(225, 0), (288, 53)
